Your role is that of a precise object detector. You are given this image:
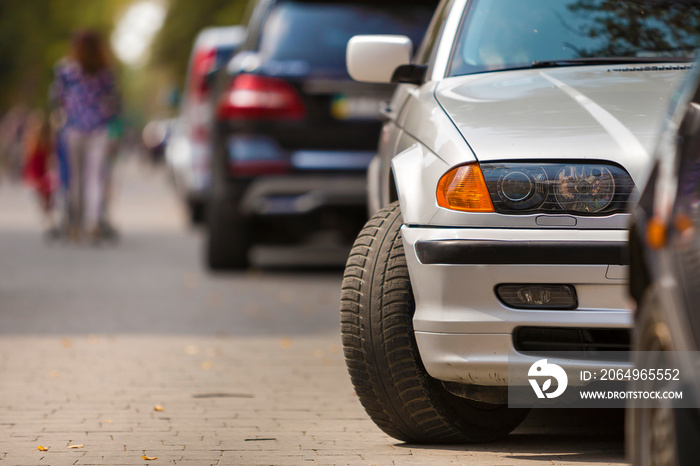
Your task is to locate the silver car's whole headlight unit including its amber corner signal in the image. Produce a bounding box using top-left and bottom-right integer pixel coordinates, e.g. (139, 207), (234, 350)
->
(437, 161), (635, 215)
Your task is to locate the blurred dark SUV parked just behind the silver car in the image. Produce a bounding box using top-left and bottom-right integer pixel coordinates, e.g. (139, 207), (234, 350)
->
(205, 0), (437, 269)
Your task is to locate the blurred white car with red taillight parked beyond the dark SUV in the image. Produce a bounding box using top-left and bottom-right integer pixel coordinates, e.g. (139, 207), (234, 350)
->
(165, 26), (245, 223)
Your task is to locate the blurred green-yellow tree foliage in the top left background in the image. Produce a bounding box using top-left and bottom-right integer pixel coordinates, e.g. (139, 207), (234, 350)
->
(0, 0), (248, 120)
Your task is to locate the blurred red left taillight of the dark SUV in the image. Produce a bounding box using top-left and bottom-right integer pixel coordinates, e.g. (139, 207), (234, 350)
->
(217, 74), (306, 120)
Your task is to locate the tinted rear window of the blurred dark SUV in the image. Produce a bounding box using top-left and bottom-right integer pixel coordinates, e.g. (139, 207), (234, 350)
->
(260, 1), (437, 71)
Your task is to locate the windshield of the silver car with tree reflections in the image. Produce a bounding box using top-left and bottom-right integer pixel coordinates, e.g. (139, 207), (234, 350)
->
(448, 0), (700, 76)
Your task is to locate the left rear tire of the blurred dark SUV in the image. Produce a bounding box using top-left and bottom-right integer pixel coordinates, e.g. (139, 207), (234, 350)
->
(205, 198), (251, 271)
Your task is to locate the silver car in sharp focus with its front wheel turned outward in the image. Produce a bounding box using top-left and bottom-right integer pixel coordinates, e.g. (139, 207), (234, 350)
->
(341, 0), (700, 443)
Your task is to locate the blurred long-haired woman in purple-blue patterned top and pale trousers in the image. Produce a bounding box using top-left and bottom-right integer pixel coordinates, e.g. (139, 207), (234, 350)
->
(52, 30), (120, 240)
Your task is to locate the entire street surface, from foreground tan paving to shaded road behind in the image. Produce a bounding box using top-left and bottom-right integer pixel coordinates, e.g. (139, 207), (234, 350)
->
(0, 158), (624, 466)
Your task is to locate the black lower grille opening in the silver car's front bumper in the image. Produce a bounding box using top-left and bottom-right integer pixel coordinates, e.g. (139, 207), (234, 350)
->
(513, 327), (631, 361)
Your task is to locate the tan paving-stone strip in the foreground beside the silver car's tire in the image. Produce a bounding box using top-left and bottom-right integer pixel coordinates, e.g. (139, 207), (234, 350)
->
(0, 335), (624, 466)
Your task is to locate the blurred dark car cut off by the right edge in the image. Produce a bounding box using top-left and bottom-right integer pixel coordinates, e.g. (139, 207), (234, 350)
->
(627, 65), (700, 465)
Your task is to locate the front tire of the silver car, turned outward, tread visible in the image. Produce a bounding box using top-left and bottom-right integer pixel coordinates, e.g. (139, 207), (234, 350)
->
(341, 203), (527, 443)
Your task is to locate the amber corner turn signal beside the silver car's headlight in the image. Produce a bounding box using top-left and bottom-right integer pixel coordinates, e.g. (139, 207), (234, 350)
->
(437, 163), (494, 212)
